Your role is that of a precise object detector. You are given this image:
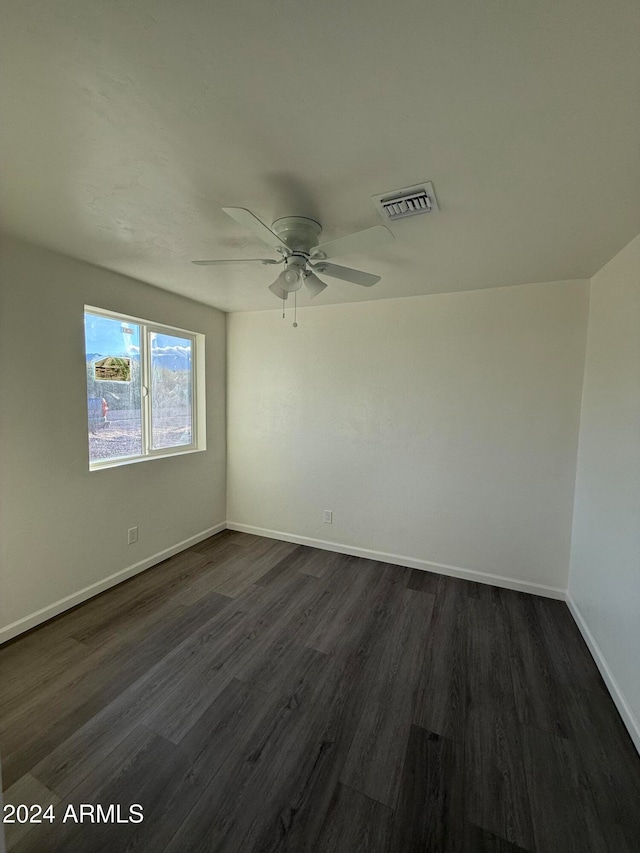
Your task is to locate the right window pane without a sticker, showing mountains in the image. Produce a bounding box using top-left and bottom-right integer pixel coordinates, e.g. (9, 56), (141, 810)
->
(150, 332), (193, 450)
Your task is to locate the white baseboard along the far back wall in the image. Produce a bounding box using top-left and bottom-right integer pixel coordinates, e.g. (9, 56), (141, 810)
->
(227, 521), (566, 601)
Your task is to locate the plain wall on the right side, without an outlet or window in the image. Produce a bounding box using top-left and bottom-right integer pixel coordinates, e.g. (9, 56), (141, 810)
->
(569, 230), (640, 750)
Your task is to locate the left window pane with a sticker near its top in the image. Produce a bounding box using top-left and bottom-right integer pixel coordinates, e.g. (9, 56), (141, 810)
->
(84, 312), (142, 462)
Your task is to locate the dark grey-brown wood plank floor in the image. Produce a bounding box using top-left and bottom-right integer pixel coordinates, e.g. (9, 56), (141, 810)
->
(0, 532), (640, 853)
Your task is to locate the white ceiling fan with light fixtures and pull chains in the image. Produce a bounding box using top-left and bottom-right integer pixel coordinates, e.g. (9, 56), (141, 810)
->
(192, 207), (395, 299)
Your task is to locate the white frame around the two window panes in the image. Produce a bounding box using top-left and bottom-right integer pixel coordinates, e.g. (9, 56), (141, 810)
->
(83, 305), (207, 471)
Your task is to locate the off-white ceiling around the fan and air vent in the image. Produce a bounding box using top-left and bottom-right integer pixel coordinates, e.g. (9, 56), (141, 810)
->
(0, 0), (640, 311)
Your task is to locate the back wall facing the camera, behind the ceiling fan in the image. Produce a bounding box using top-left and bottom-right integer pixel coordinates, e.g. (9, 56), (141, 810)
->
(227, 281), (589, 597)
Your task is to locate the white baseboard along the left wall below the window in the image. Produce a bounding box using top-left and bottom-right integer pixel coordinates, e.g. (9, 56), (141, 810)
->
(0, 521), (227, 645)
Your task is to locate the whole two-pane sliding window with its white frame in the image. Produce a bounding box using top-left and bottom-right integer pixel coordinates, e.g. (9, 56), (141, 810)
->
(84, 306), (205, 470)
